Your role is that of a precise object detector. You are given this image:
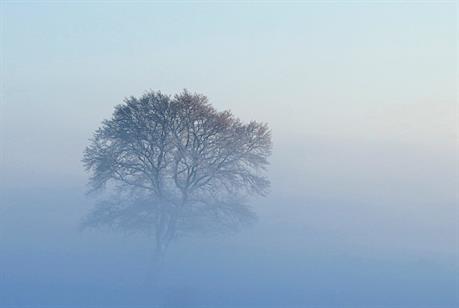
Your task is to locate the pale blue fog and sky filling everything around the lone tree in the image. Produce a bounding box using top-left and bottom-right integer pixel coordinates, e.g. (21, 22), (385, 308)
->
(0, 2), (458, 307)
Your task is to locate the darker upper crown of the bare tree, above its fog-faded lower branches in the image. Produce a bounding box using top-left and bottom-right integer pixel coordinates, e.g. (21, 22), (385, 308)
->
(83, 90), (271, 206)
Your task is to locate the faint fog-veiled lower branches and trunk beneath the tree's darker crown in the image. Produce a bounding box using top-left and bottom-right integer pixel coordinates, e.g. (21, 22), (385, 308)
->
(80, 193), (257, 282)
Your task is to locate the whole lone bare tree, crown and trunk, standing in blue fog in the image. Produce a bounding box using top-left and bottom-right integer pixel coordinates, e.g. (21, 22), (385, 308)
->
(83, 90), (271, 255)
